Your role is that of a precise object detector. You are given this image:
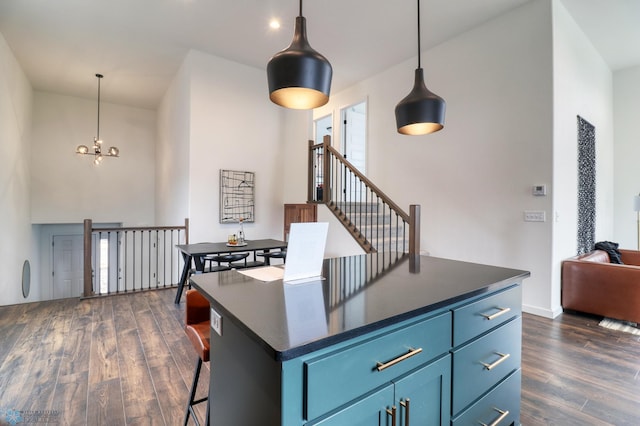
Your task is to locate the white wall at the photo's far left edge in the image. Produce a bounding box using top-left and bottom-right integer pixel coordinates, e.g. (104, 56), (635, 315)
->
(0, 34), (34, 305)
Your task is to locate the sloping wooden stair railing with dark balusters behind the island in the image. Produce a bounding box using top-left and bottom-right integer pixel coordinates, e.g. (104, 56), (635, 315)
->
(307, 136), (420, 254)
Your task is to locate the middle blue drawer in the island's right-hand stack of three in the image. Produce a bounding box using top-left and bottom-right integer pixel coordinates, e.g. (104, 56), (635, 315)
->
(452, 317), (522, 414)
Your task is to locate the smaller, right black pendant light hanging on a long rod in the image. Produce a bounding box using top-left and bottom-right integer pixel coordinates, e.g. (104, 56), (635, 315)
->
(396, 0), (446, 135)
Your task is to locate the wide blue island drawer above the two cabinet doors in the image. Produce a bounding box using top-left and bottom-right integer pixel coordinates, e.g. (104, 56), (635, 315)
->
(304, 312), (451, 420)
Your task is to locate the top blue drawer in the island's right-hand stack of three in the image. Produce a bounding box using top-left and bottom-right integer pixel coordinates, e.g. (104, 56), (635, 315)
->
(453, 285), (522, 346)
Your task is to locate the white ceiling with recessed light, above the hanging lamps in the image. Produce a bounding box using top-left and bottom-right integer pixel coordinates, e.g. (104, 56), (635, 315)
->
(0, 0), (640, 109)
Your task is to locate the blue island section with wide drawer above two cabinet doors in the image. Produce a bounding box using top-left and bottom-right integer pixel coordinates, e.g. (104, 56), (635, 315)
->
(302, 312), (451, 426)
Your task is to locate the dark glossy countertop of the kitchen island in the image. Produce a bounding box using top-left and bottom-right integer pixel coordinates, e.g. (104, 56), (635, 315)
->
(191, 253), (530, 361)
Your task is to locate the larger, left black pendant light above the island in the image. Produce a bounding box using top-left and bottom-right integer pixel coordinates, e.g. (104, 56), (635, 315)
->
(267, 0), (333, 109)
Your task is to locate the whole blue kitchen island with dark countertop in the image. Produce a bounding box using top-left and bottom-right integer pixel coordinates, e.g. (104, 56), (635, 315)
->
(191, 253), (529, 426)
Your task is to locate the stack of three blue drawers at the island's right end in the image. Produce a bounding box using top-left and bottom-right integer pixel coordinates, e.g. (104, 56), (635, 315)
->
(451, 286), (522, 426)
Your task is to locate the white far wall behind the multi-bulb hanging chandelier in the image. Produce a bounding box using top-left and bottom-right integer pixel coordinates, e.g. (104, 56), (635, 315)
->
(31, 93), (156, 226)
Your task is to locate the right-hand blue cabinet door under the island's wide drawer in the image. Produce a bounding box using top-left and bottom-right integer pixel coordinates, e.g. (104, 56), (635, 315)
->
(395, 356), (451, 426)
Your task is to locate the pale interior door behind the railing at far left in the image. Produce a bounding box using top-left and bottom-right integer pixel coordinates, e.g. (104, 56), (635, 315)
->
(51, 235), (84, 299)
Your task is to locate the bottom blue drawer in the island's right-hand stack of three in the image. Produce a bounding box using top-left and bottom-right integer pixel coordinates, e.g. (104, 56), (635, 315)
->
(451, 369), (521, 426)
